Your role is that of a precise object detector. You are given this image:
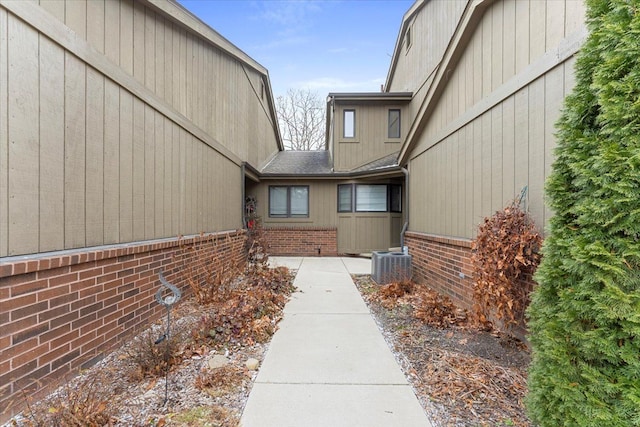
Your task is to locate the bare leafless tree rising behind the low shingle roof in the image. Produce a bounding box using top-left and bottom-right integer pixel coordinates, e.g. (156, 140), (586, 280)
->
(276, 89), (325, 150)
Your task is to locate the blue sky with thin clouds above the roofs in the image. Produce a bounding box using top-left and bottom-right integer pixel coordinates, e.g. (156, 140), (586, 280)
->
(179, 0), (413, 97)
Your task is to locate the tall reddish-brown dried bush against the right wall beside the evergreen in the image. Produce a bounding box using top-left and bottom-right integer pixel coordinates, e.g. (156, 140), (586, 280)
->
(471, 201), (542, 329)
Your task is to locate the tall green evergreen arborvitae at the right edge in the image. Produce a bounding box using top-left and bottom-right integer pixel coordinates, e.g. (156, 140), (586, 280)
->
(527, 0), (640, 427)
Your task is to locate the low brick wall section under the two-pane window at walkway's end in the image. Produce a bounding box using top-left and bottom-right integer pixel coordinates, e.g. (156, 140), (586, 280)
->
(264, 227), (338, 256)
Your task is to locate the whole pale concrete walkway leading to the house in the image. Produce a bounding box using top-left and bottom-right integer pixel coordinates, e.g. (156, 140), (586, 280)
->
(241, 258), (431, 427)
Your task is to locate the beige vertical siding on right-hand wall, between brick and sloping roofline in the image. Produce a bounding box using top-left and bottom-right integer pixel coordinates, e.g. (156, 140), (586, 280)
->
(410, 0), (583, 238)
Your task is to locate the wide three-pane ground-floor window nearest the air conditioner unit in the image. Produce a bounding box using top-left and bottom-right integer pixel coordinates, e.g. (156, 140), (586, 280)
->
(338, 184), (402, 212)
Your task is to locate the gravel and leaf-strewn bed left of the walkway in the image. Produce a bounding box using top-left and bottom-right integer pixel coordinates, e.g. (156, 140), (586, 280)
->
(7, 268), (295, 427)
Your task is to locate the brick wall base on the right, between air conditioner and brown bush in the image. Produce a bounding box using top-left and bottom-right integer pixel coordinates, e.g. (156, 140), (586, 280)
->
(405, 232), (473, 309)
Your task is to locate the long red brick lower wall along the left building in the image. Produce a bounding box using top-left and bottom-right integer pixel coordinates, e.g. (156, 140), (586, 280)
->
(0, 231), (245, 423)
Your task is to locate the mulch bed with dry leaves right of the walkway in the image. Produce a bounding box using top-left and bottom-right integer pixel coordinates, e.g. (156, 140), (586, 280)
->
(353, 275), (532, 427)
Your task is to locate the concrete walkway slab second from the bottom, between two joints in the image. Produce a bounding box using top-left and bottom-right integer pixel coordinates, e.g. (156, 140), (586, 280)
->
(259, 313), (407, 385)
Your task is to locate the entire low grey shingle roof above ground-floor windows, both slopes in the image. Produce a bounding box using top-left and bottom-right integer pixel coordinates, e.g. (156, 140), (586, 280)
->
(262, 150), (399, 176)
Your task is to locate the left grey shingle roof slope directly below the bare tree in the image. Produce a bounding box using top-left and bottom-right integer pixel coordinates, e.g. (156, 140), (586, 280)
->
(262, 150), (331, 175)
